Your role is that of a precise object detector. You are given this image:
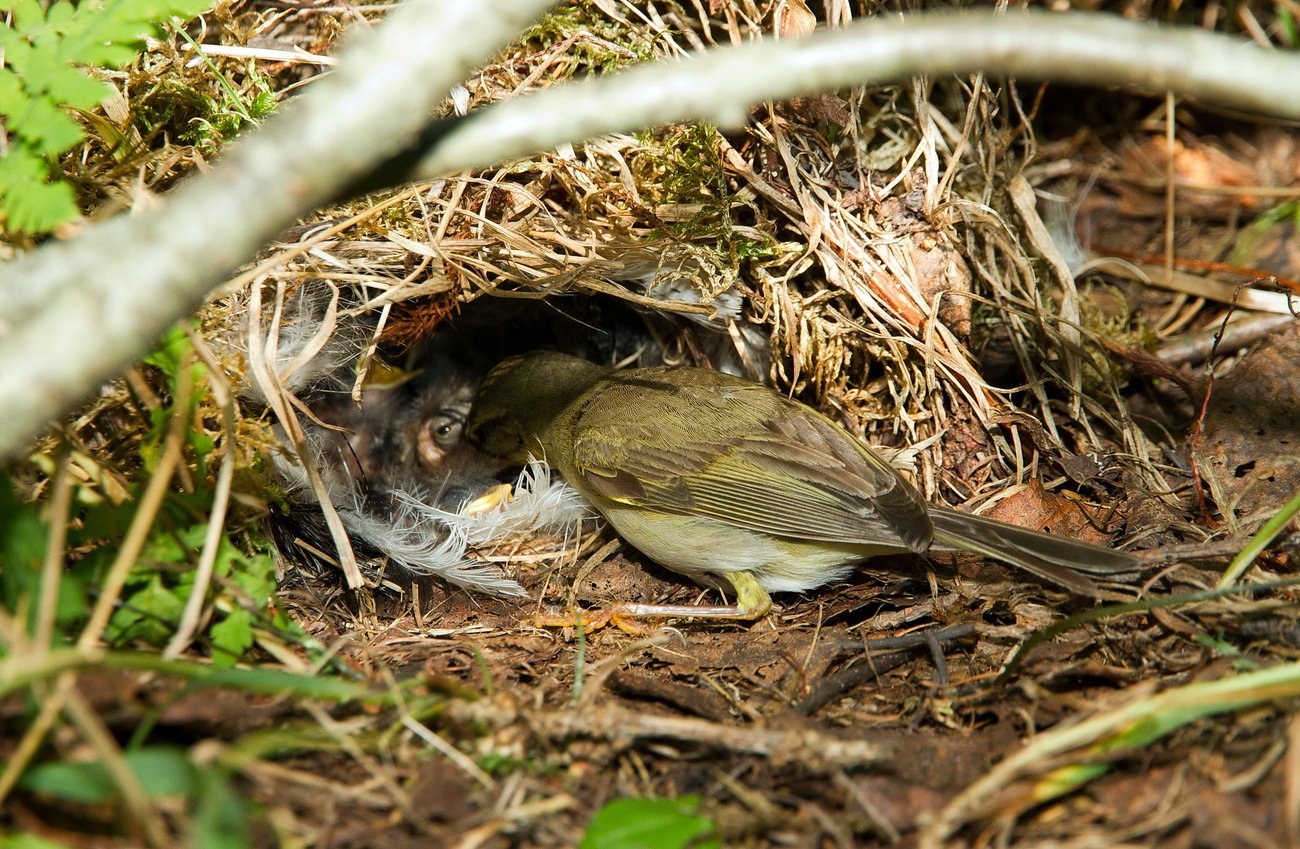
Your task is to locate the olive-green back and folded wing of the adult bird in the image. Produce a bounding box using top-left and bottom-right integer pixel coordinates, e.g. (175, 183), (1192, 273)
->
(573, 372), (931, 551)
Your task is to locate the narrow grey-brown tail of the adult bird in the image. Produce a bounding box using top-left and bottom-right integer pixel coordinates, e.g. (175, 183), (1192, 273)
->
(930, 507), (1141, 597)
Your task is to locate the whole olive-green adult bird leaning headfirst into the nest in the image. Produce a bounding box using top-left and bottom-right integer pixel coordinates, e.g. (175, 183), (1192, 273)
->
(467, 352), (1138, 619)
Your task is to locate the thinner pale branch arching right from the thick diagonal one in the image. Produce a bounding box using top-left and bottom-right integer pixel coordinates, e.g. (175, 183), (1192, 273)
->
(413, 10), (1300, 179)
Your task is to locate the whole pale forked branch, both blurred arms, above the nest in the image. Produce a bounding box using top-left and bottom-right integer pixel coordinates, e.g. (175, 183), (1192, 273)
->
(0, 8), (1300, 455)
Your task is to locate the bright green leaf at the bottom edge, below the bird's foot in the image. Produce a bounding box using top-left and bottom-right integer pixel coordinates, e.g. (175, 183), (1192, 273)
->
(581, 796), (722, 849)
